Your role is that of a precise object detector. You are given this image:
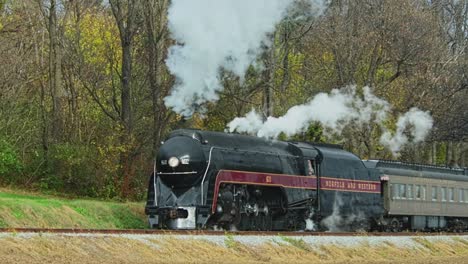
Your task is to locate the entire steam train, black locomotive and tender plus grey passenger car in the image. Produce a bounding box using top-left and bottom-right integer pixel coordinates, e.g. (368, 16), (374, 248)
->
(145, 129), (468, 231)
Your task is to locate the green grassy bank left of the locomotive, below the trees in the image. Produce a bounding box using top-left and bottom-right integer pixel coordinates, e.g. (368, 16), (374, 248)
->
(0, 189), (147, 229)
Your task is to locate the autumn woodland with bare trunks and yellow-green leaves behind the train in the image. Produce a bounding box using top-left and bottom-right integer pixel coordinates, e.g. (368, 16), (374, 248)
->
(0, 0), (468, 199)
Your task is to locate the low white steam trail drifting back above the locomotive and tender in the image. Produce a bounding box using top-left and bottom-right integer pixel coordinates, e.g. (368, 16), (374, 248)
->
(227, 86), (433, 155)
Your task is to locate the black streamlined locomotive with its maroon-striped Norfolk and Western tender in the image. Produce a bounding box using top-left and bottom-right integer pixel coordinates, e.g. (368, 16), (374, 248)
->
(145, 129), (386, 230)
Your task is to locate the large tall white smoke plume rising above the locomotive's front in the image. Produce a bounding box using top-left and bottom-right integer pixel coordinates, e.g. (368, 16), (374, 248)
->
(165, 0), (321, 117)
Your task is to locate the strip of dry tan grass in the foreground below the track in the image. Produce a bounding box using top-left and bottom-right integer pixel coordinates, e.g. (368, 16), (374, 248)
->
(0, 236), (468, 264)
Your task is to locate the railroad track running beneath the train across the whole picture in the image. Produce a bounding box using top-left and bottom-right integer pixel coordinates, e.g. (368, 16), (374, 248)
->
(0, 228), (468, 237)
